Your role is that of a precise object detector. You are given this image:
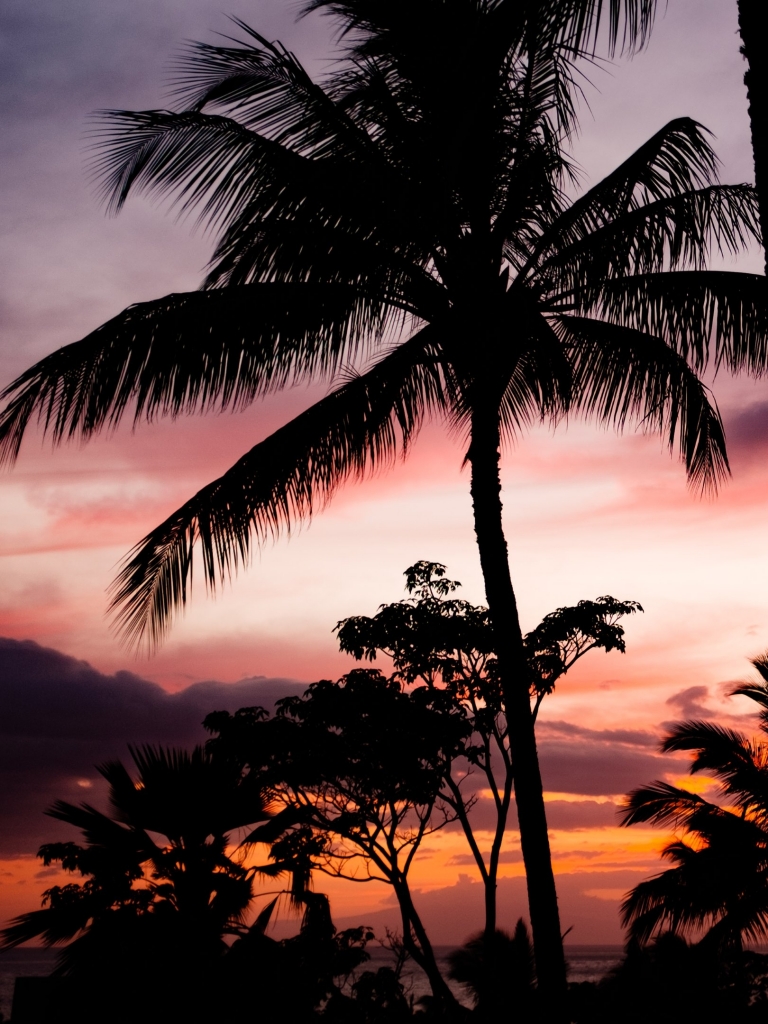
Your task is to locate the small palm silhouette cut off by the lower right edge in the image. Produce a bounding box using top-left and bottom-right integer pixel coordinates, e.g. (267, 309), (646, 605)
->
(623, 654), (768, 951)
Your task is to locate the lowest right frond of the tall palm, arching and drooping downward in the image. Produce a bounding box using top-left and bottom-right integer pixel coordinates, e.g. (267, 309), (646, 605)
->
(556, 316), (729, 490)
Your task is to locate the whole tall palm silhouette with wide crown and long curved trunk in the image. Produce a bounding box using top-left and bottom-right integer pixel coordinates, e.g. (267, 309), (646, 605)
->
(0, 0), (765, 999)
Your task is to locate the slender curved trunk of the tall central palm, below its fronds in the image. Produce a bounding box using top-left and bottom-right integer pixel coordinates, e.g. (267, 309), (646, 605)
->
(468, 410), (566, 1024)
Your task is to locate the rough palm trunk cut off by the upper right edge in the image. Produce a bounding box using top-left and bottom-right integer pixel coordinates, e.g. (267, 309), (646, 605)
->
(738, 0), (768, 274)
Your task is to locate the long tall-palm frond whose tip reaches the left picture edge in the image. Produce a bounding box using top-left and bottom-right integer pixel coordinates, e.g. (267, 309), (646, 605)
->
(0, 284), (392, 462)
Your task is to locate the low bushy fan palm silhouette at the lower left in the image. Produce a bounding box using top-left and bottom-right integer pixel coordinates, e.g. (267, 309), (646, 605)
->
(2, 746), (268, 974)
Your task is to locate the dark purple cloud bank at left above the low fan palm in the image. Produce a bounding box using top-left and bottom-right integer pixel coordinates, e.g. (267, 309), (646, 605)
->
(0, 639), (305, 856)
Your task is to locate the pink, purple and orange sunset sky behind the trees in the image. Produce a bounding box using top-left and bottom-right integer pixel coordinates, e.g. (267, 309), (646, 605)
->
(0, 0), (768, 942)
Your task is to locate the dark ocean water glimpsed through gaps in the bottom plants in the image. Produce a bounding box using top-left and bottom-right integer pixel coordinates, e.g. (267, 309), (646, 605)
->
(0, 944), (622, 1021)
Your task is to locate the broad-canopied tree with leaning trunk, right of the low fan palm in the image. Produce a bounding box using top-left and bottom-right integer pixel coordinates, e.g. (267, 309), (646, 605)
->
(205, 669), (466, 1009)
